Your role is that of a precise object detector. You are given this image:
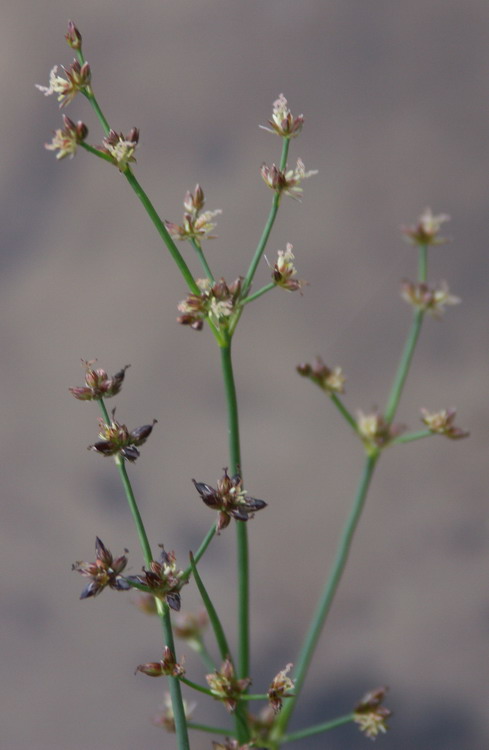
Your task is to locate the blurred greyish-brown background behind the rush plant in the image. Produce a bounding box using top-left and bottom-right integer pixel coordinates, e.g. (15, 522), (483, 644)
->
(0, 0), (489, 750)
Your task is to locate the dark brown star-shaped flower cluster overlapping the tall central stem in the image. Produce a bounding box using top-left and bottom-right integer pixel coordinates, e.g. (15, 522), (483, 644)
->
(192, 469), (267, 534)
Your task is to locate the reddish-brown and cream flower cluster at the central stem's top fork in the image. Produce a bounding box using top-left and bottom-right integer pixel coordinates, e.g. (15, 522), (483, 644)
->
(177, 276), (242, 331)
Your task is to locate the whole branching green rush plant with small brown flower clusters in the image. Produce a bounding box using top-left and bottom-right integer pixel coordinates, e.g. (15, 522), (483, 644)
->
(39, 22), (467, 750)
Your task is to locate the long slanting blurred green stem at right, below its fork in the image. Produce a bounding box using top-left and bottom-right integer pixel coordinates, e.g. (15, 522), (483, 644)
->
(273, 453), (379, 747)
